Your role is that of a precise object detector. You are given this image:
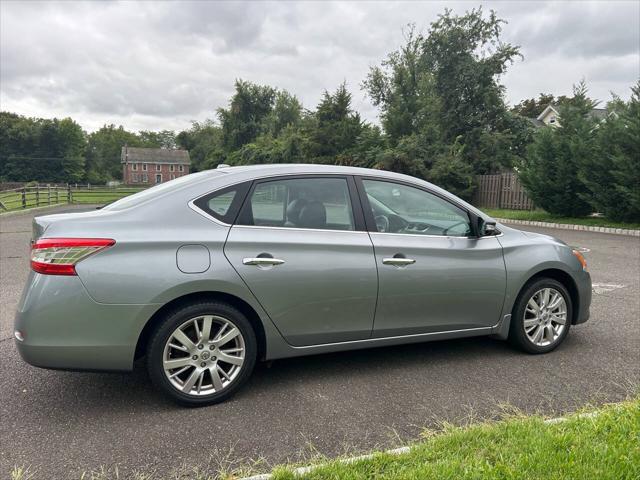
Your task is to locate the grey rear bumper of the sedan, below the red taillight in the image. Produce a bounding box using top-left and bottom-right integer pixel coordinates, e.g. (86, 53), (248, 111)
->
(14, 272), (157, 370)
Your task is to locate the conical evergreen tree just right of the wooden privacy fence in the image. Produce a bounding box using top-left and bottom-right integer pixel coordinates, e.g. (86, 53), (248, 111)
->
(520, 83), (597, 216)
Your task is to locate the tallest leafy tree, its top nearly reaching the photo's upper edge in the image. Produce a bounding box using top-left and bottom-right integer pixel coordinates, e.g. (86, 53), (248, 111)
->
(423, 8), (520, 173)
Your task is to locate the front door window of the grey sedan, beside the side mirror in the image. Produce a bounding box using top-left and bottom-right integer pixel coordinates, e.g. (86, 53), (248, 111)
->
(362, 180), (471, 237)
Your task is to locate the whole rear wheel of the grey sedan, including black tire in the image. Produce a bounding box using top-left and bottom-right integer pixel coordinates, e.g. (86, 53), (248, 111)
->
(147, 301), (257, 407)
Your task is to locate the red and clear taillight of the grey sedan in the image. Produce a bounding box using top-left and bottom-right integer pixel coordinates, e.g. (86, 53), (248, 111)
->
(31, 238), (116, 275)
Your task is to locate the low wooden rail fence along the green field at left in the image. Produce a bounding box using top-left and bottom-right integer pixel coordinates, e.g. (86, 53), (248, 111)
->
(0, 184), (142, 213)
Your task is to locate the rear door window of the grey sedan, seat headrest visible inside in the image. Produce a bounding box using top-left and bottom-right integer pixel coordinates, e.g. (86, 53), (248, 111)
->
(238, 178), (355, 230)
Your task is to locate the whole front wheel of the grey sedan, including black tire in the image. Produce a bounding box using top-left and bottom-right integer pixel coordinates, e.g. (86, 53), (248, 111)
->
(509, 278), (573, 354)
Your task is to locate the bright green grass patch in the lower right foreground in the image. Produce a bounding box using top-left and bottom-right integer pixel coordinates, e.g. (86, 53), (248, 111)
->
(274, 397), (640, 480)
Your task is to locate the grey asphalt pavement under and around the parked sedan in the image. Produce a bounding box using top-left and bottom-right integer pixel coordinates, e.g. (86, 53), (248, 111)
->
(0, 207), (640, 479)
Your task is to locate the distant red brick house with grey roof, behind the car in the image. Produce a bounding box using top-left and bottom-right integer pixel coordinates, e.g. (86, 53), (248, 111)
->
(120, 145), (191, 185)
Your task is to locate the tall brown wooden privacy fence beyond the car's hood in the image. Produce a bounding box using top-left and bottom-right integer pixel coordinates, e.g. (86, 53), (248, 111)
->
(473, 172), (534, 210)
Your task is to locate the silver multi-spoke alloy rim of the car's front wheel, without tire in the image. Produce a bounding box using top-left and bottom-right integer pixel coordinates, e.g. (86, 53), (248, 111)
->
(523, 288), (567, 347)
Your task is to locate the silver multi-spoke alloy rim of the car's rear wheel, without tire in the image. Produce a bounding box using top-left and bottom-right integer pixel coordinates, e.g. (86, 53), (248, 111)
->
(162, 315), (245, 397)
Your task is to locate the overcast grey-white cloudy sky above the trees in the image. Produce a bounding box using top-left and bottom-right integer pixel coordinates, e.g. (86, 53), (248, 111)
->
(0, 0), (640, 131)
